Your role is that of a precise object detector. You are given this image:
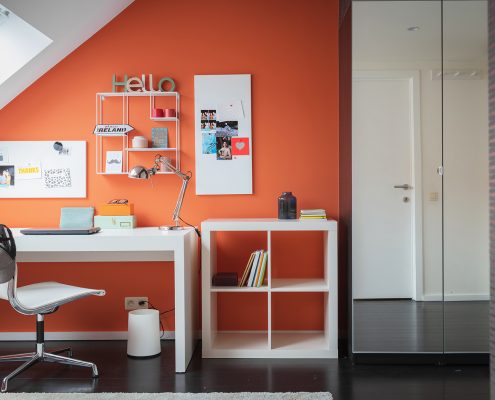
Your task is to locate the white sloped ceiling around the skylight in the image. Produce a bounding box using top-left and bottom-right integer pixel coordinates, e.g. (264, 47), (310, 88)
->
(0, 0), (134, 109)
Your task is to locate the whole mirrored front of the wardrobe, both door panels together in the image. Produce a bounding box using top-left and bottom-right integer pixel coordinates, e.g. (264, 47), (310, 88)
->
(352, 0), (489, 353)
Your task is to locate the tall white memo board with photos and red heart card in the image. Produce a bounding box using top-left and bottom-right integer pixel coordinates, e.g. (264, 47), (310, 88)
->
(194, 75), (253, 195)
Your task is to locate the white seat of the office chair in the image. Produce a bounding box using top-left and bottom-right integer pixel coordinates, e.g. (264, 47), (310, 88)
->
(16, 282), (105, 309)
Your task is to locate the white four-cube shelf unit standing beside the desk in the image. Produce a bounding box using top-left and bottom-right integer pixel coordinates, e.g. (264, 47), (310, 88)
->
(201, 219), (338, 358)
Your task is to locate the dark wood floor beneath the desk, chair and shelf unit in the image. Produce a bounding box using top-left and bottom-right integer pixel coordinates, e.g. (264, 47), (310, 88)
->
(0, 341), (489, 400)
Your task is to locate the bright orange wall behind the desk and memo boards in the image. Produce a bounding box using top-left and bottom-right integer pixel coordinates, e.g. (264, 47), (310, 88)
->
(0, 0), (339, 331)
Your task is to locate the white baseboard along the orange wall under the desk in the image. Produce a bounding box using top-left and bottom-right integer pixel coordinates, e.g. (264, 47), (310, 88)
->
(0, 331), (175, 341)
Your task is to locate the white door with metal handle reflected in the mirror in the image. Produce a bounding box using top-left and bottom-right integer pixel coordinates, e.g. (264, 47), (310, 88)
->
(352, 71), (422, 299)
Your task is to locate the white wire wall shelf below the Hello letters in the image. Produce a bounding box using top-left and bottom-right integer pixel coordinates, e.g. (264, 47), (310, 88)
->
(95, 92), (180, 175)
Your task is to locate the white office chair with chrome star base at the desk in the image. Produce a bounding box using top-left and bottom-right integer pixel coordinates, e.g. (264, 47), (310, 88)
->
(0, 224), (105, 392)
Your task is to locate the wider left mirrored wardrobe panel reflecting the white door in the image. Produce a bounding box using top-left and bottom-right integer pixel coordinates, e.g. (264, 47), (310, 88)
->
(352, 1), (444, 353)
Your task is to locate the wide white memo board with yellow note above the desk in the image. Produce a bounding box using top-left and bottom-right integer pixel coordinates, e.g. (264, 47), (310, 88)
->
(0, 140), (86, 199)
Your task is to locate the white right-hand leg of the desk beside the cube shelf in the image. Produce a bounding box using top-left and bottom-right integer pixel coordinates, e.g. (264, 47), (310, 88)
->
(174, 231), (199, 372)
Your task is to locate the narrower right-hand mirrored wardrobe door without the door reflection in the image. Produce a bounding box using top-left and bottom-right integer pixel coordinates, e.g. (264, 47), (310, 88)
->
(443, 0), (489, 353)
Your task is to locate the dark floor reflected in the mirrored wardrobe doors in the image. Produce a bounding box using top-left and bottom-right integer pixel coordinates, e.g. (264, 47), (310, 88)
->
(353, 300), (489, 353)
